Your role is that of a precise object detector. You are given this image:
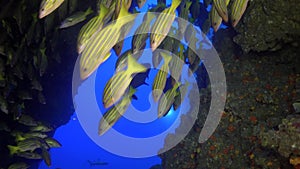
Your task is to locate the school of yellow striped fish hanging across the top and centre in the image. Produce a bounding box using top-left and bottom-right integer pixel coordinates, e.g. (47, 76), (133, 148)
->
(39, 0), (248, 135)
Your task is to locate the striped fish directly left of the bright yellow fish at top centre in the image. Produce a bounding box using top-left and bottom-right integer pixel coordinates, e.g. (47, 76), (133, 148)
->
(131, 12), (155, 54)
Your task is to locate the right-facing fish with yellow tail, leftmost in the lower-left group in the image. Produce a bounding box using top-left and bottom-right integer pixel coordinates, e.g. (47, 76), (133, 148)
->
(7, 138), (42, 155)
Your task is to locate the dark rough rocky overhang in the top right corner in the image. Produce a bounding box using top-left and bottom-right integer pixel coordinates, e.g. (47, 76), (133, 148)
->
(234, 0), (300, 53)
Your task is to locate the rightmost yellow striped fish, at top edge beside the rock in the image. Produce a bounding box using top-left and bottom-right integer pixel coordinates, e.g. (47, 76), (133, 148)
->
(230, 0), (249, 27)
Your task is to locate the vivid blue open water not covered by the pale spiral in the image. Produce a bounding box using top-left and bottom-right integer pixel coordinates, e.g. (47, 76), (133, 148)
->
(39, 0), (211, 169)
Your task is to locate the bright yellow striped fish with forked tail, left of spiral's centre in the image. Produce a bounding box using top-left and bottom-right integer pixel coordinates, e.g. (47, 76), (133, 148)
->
(102, 55), (147, 108)
